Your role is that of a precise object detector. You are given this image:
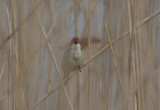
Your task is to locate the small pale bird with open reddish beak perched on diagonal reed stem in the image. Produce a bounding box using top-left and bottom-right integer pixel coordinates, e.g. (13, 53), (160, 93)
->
(62, 37), (85, 85)
